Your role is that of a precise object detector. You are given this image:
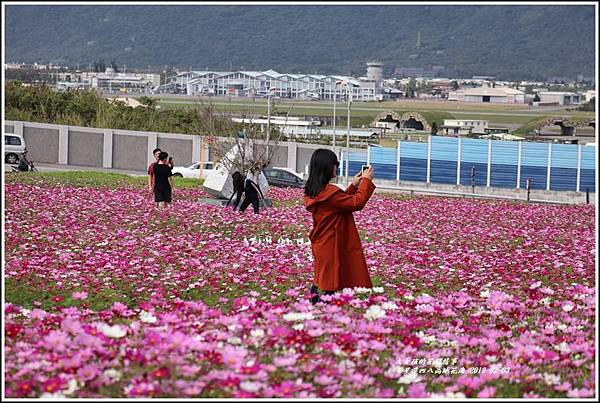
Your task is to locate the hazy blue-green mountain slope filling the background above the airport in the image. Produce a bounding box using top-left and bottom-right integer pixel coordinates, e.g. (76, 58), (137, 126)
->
(5, 5), (595, 80)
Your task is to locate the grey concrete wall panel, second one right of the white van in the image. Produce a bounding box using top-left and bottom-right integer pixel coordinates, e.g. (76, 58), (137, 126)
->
(67, 130), (104, 168)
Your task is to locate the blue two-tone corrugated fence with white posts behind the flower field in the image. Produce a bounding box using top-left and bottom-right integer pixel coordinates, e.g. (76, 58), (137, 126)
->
(340, 136), (596, 192)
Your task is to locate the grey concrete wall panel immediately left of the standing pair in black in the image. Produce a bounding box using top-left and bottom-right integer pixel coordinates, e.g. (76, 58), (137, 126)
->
(112, 130), (152, 171)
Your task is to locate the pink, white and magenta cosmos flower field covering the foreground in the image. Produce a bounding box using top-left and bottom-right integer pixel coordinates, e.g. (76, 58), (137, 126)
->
(4, 177), (597, 398)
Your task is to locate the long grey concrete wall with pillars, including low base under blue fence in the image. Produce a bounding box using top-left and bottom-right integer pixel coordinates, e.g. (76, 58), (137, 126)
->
(5, 121), (595, 203)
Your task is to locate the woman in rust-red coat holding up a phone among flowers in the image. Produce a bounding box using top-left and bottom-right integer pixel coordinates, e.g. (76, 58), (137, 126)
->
(304, 149), (375, 303)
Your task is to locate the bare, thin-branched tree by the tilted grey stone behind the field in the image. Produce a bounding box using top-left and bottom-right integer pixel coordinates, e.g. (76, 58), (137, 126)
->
(187, 98), (293, 174)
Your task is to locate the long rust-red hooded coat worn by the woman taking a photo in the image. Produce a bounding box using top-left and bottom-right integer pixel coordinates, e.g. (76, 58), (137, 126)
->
(304, 178), (375, 291)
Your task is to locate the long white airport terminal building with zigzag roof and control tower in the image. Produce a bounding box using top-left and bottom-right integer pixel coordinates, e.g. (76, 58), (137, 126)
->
(166, 64), (381, 101)
